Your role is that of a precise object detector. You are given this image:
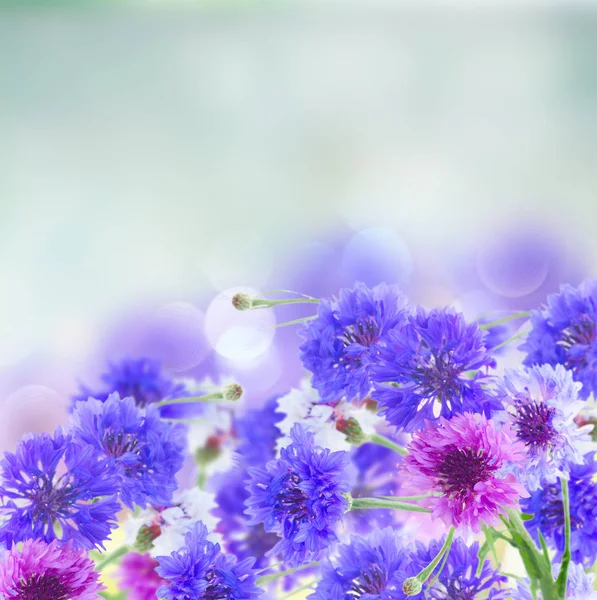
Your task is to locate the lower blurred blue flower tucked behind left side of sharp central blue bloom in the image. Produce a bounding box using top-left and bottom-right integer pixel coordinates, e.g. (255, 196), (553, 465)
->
(214, 468), (280, 569)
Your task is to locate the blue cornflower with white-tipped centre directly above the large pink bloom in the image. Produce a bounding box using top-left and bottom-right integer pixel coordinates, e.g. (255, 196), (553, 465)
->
(371, 308), (499, 431)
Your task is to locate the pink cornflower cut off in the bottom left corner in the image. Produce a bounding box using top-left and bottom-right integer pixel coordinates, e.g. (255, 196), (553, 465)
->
(0, 540), (104, 600)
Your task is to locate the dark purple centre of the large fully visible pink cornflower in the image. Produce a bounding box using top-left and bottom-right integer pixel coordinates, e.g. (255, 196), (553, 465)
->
(436, 447), (497, 501)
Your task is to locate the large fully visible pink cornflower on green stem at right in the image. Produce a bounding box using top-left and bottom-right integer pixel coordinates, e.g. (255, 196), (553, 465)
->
(403, 413), (528, 533)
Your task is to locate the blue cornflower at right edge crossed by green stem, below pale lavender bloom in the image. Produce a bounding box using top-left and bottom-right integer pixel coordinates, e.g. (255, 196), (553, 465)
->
(520, 453), (597, 565)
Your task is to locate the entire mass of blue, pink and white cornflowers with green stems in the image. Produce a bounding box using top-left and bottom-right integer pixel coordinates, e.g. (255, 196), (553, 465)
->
(0, 282), (597, 600)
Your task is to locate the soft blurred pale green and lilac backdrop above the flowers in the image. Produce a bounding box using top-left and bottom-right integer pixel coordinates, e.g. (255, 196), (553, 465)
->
(0, 1), (597, 449)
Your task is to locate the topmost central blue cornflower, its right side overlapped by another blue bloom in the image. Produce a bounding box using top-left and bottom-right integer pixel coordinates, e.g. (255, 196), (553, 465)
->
(299, 283), (406, 402)
